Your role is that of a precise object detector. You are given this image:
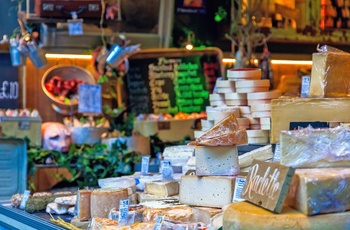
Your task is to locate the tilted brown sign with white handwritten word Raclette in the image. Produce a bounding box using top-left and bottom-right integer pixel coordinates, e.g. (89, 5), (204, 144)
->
(241, 160), (295, 213)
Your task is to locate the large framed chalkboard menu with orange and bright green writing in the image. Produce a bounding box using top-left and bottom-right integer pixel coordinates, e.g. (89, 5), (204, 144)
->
(125, 48), (222, 114)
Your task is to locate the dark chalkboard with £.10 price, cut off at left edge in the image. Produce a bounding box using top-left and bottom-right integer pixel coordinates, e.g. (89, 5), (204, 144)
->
(0, 53), (20, 109)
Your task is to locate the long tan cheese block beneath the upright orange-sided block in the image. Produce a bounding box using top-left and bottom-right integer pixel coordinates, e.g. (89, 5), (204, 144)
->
(271, 98), (350, 143)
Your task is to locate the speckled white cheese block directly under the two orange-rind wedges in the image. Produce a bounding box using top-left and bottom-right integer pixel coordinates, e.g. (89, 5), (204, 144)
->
(195, 145), (239, 176)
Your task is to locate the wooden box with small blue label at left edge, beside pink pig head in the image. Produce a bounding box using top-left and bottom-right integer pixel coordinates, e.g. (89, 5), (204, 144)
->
(0, 117), (42, 146)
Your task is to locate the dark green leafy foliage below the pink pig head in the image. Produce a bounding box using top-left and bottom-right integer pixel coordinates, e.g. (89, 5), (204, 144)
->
(27, 139), (141, 188)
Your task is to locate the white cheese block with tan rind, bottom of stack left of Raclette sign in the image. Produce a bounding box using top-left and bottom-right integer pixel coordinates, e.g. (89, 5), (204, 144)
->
(179, 176), (235, 208)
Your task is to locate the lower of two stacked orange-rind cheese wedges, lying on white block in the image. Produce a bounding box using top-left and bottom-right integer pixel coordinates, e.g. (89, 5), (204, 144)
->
(192, 129), (248, 146)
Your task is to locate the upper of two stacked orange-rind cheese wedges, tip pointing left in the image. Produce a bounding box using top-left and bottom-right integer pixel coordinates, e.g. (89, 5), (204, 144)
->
(197, 114), (239, 142)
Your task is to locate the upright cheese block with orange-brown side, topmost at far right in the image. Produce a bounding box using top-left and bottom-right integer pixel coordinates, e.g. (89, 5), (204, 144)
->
(309, 52), (350, 98)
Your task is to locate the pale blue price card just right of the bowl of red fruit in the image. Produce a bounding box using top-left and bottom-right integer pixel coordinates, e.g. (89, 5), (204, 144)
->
(78, 84), (102, 114)
